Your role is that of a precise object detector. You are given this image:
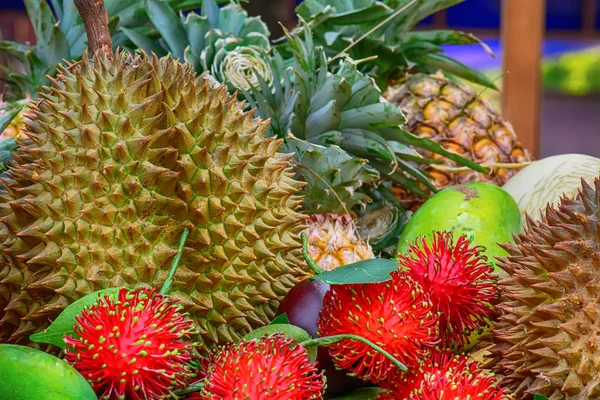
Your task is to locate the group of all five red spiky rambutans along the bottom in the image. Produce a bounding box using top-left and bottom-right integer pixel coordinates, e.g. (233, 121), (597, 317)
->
(65, 232), (506, 400)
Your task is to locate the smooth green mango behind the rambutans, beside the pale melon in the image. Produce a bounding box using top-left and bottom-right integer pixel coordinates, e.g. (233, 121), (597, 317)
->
(398, 182), (521, 272)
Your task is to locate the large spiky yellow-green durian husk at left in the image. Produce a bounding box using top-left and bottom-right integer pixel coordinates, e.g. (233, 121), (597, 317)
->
(0, 53), (308, 345)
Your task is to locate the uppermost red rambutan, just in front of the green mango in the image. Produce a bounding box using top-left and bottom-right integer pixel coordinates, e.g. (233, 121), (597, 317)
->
(398, 232), (499, 348)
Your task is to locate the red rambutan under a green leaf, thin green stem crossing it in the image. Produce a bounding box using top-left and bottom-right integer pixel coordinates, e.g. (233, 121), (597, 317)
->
(318, 271), (439, 382)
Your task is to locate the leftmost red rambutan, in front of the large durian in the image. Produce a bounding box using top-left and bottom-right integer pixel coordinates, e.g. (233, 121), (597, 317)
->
(65, 289), (196, 400)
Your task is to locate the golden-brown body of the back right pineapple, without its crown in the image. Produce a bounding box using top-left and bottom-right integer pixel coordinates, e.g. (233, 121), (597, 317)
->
(384, 73), (531, 210)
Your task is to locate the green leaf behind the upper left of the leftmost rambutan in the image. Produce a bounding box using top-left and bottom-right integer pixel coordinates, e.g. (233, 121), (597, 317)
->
(29, 288), (121, 349)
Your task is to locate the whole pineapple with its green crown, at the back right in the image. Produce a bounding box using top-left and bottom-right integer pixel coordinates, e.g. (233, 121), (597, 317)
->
(296, 0), (531, 210)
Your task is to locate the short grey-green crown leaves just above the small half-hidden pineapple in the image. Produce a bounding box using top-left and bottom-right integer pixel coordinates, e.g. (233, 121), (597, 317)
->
(286, 135), (379, 214)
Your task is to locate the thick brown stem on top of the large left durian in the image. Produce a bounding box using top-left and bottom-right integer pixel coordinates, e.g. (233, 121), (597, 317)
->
(75, 0), (112, 60)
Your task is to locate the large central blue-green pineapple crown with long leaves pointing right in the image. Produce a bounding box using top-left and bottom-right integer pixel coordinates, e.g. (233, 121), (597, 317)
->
(243, 23), (485, 197)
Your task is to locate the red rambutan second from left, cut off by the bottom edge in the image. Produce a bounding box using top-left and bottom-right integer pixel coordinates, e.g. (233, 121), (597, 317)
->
(200, 334), (325, 400)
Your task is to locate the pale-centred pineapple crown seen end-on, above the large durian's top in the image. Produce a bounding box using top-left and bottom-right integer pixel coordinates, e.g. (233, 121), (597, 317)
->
(127, 0), (272, 91)
